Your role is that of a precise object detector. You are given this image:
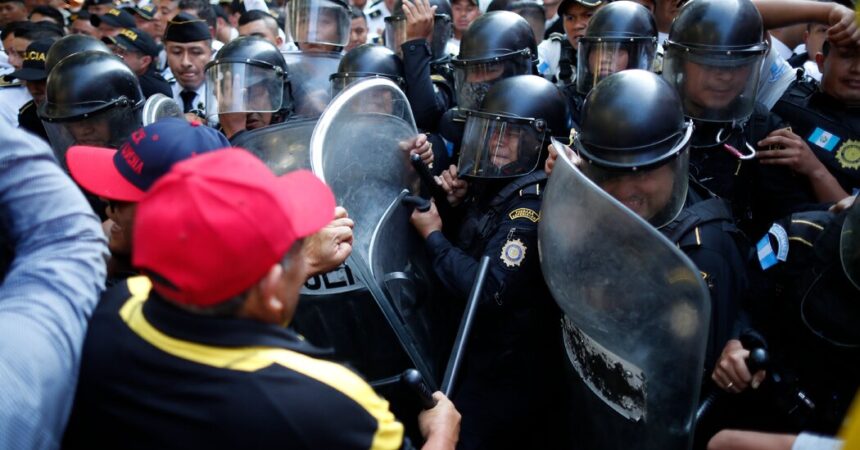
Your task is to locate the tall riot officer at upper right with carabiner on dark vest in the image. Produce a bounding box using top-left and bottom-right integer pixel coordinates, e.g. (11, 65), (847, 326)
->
(663, 0), (816, 235)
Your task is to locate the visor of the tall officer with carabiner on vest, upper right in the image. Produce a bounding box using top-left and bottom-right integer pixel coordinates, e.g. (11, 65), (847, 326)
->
(663, 46), (764, 122)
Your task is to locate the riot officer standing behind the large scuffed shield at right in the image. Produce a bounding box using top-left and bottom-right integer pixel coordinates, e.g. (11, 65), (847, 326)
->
(574, 70), (749, 374)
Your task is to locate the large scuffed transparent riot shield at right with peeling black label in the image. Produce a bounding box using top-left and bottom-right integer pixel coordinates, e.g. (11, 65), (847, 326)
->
(538, 152), (710, 450)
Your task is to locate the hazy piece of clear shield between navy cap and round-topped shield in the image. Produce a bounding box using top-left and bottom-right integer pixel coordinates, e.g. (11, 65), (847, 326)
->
(233, 117), (317, 176)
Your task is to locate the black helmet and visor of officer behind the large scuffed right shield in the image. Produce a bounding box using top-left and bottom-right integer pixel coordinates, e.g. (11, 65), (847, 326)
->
(574, 70), (698, 228)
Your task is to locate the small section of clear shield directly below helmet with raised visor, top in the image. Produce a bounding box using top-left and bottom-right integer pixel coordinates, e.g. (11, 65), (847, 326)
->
(283, 52), (341, 117)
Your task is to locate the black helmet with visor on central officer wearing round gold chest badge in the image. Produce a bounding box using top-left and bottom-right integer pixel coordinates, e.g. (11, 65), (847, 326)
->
(458, 75), (571, 178)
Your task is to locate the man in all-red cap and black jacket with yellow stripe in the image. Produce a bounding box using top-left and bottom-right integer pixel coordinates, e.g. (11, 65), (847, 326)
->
(65, 149), (459, 449)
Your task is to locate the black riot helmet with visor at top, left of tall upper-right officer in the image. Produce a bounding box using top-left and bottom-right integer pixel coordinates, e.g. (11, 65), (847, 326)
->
(576, 0), (657, 94)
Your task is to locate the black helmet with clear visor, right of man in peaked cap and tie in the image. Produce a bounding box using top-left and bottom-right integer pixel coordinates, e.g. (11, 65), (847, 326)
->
(206, 36), (291, 117)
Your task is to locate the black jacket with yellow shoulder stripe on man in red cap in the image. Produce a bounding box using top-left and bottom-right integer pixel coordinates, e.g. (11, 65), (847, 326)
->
(64, 277), (403, 449)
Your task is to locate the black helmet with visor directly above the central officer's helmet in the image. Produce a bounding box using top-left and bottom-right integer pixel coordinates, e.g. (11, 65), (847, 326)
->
(451, 11), (537, 110)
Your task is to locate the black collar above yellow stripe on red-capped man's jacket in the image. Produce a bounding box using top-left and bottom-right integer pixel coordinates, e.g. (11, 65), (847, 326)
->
(143, 291), (331, 356)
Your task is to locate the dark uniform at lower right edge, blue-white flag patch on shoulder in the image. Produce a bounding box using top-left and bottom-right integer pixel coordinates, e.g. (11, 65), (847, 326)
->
(750, 206), (860, 435)
